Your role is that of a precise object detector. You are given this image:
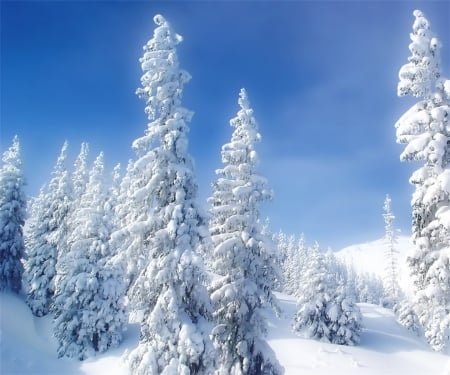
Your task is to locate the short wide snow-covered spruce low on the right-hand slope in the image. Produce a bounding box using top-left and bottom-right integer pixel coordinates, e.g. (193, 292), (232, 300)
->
(292, 247), (362, 345)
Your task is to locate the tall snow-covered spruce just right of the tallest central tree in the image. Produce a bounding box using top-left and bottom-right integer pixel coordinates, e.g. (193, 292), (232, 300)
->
(209, 89), (282, 374)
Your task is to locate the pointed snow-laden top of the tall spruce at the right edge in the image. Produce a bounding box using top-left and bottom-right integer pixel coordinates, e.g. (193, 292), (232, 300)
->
(397, 10), (441, 98)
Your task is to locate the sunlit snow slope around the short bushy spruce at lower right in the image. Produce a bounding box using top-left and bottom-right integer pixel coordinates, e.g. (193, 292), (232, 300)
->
(269, 294), (450, 375)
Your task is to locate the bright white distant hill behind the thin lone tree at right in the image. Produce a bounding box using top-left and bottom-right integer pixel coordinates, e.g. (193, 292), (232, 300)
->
(335, 236), (413, 294)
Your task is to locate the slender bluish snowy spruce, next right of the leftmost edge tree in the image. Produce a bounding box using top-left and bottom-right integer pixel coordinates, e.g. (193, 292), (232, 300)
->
(24, 142), (72, 316)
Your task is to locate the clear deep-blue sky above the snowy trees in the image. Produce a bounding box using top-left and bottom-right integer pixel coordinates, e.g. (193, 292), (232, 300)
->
(0, 0), (450, 249)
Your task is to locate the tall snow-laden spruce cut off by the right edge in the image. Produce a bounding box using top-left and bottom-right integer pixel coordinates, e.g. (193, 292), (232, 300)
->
(395, 10), (450, 351)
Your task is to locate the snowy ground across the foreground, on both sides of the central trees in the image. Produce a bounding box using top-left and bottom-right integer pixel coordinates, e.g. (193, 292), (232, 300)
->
(0, 293), (450, 375)
